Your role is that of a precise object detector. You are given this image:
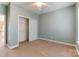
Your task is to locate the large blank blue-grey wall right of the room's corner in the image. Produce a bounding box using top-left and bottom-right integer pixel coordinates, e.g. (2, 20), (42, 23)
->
(39, 6), (76, 44)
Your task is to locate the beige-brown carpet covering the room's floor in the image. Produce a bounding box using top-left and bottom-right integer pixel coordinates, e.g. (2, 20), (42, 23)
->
(0, 40), (78, 57)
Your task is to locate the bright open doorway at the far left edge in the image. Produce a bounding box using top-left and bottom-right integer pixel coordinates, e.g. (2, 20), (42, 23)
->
(0, 14), (6, 47)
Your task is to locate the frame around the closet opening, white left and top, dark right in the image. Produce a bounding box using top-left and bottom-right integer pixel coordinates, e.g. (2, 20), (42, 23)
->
(18, 15), (29, 45)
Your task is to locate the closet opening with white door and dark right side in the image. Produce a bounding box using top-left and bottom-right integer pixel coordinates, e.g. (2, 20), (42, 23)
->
(18, 16), (29, 43)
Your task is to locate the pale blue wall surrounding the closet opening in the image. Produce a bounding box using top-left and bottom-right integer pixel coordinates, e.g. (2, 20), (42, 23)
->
(8, 3), (38, 46)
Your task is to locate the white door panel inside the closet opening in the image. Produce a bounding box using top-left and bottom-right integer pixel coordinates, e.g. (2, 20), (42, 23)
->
(18, 17), (27, 42)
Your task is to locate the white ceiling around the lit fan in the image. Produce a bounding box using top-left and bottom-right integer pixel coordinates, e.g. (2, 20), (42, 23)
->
(0, 2), (75, 14)
